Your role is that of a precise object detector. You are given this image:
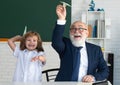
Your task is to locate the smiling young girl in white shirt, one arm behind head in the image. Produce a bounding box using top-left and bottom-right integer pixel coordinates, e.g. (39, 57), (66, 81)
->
(8, 31), (46, 82)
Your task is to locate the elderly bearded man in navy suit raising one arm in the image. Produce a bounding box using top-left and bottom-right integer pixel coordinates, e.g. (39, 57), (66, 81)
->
(52, 5), (109, 82)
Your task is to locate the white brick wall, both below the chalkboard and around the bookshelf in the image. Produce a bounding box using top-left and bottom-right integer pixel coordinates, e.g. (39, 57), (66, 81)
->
(0, 0), (120, 85)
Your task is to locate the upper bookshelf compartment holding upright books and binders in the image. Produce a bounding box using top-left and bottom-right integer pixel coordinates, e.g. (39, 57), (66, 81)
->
(86, 11), (105, 38)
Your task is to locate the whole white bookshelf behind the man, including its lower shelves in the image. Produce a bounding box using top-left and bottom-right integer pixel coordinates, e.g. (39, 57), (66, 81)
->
(81, 11), (110, 61)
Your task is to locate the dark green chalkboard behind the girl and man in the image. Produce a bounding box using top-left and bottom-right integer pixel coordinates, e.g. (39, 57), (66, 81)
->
(0, 0), (71, 41)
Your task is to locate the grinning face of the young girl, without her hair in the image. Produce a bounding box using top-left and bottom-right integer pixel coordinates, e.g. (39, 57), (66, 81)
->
(25, 36), (38, 51)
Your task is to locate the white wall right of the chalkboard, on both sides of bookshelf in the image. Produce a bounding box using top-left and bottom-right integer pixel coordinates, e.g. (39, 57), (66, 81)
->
(71, 0), (120, 85)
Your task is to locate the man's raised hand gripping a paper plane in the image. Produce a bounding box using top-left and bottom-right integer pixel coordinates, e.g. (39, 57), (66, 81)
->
(56, 5), (66, 20)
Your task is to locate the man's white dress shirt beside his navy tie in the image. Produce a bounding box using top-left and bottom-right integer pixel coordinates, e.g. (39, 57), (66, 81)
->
(78, 43), (88, 81)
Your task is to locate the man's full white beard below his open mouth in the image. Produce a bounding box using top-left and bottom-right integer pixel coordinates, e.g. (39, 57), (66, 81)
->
(70, 35), (85, 47)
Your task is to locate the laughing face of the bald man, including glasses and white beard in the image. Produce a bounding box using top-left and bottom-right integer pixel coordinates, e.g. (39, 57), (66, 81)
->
(70, 21), (88, 47)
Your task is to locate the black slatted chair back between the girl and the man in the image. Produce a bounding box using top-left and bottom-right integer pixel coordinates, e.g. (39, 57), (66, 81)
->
(42, 68), (59, 82)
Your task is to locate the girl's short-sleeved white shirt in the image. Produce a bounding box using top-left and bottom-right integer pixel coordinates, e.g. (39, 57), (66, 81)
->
(13, 46), (44, 82)
